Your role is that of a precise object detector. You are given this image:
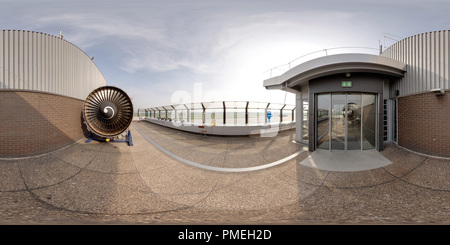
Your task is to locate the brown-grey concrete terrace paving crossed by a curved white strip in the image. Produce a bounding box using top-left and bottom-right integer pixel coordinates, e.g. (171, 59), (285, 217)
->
(0, 122), (450, 224)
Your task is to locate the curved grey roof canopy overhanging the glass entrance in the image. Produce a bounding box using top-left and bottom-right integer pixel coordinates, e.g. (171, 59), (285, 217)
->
(264, 54), (406, 92)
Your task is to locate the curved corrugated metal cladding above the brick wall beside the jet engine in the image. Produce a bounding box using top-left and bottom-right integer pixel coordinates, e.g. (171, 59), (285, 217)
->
(0, 30), (106, 100)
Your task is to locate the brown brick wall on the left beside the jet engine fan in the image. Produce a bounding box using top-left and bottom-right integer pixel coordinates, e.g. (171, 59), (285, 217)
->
(0, 90), (84, 158)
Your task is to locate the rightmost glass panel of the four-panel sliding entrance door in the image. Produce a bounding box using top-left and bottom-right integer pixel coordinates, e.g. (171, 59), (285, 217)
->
(362, 94), (377, 150)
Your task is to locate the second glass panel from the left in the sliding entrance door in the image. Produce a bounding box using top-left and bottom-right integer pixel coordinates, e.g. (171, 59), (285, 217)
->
(331, 94), (346, 150)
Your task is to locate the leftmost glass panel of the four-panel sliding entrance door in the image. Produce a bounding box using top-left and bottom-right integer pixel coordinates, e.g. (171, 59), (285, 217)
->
(317, 94), (330, 150)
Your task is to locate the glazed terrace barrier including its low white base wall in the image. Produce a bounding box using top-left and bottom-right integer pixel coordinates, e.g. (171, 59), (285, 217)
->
(138, 101), (296, 137)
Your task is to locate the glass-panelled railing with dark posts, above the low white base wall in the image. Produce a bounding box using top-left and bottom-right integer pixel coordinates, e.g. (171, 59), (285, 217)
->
(138, 101), (296, 126)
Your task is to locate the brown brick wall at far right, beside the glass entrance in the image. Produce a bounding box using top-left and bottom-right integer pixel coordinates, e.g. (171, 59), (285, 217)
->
(398, 91), (450, 157)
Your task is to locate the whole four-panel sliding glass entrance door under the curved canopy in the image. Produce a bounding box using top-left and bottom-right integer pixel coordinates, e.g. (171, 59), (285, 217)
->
(316, 93), (377, 151)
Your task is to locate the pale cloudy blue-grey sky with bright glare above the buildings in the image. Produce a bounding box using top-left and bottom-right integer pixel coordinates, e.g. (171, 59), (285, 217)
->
(0, 0), (450, 109)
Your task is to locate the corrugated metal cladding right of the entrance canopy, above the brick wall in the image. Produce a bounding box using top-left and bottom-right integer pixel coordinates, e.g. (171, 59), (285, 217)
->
(381, 30), (450, 97)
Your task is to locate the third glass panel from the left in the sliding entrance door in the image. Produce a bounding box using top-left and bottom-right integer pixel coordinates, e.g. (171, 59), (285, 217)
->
(347, 94), (361, 150)
